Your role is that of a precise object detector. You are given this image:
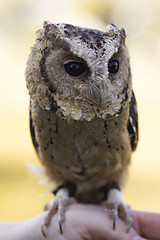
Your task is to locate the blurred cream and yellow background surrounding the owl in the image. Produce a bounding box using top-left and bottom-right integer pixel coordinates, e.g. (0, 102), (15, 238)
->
(0, 0), (160, 221)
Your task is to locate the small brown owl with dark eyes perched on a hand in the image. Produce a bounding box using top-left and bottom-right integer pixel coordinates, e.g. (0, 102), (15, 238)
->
(25, 22), (138, 235)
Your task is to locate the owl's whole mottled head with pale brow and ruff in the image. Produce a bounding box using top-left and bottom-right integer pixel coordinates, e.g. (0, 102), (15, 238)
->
(26, 22), (132, 120)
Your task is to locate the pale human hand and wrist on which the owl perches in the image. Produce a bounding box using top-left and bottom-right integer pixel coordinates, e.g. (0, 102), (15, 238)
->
(0, 203), (160, 240)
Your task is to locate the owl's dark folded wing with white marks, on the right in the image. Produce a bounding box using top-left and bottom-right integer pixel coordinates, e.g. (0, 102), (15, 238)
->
(127, 91), (138, 151)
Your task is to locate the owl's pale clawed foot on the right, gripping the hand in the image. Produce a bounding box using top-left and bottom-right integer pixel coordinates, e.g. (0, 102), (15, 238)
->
(103, 188), (133, 233)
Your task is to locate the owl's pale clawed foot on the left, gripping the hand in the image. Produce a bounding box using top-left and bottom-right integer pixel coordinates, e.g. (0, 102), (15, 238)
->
(41, 188), (75, 237)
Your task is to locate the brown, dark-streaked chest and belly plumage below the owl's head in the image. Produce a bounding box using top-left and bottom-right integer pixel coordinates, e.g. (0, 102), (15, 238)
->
(32, 102), (131, 183)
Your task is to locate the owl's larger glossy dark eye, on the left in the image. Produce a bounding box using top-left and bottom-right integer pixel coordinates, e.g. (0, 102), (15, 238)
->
(64, 61), (88, 77)
